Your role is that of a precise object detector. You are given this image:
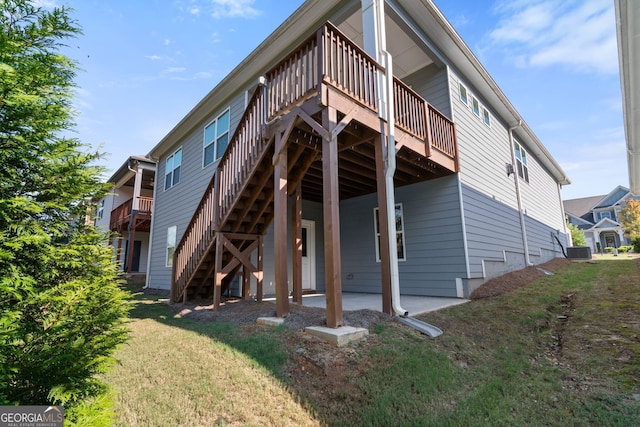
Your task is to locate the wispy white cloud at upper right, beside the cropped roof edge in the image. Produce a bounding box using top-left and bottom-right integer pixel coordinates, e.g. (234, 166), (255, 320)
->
(490, 0), (618, 74)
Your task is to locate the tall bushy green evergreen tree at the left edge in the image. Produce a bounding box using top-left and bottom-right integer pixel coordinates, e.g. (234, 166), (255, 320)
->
(0, 0), (127, 424)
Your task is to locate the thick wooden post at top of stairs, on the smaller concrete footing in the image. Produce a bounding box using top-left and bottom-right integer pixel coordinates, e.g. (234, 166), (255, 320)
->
(273, 137), (289, 317)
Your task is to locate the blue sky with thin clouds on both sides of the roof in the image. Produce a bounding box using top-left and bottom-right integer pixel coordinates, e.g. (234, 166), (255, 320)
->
(48, 0), (628, 199)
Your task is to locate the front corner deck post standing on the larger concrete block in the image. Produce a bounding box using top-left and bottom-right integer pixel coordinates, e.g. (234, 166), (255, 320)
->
(322, 107), (343, 328)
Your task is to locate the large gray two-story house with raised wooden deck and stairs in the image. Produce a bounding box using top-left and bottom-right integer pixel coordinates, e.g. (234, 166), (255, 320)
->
(147, 0), (570, 326)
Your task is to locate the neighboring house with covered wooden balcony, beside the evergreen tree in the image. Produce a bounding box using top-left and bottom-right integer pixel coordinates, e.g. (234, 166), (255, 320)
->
(95, 156), (156, 273)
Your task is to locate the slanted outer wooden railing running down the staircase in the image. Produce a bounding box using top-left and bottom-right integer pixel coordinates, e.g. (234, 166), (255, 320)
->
(172, 87), (268, 298)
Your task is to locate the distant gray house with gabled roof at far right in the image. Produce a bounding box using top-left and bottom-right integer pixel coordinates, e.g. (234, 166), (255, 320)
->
(563, 185), (635, 253)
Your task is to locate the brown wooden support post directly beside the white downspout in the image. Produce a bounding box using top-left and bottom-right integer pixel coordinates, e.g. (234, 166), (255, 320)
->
(373, 135), (395, 314)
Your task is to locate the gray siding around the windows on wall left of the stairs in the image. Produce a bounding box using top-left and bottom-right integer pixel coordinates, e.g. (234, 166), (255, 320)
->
(149, 91), (250, 289)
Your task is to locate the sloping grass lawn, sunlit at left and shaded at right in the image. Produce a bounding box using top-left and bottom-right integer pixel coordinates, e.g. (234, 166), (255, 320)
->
(107, 257), (640, 426)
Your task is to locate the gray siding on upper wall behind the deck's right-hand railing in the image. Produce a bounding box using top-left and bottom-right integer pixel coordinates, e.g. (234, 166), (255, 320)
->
(402, 64), (451, 118)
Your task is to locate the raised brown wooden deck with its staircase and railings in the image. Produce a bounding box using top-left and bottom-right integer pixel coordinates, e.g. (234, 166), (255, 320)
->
(171, 23), (458, 326)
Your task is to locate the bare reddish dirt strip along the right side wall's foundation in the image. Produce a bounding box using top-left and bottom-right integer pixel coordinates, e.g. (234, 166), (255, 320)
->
(471, 258), (571, 299)
